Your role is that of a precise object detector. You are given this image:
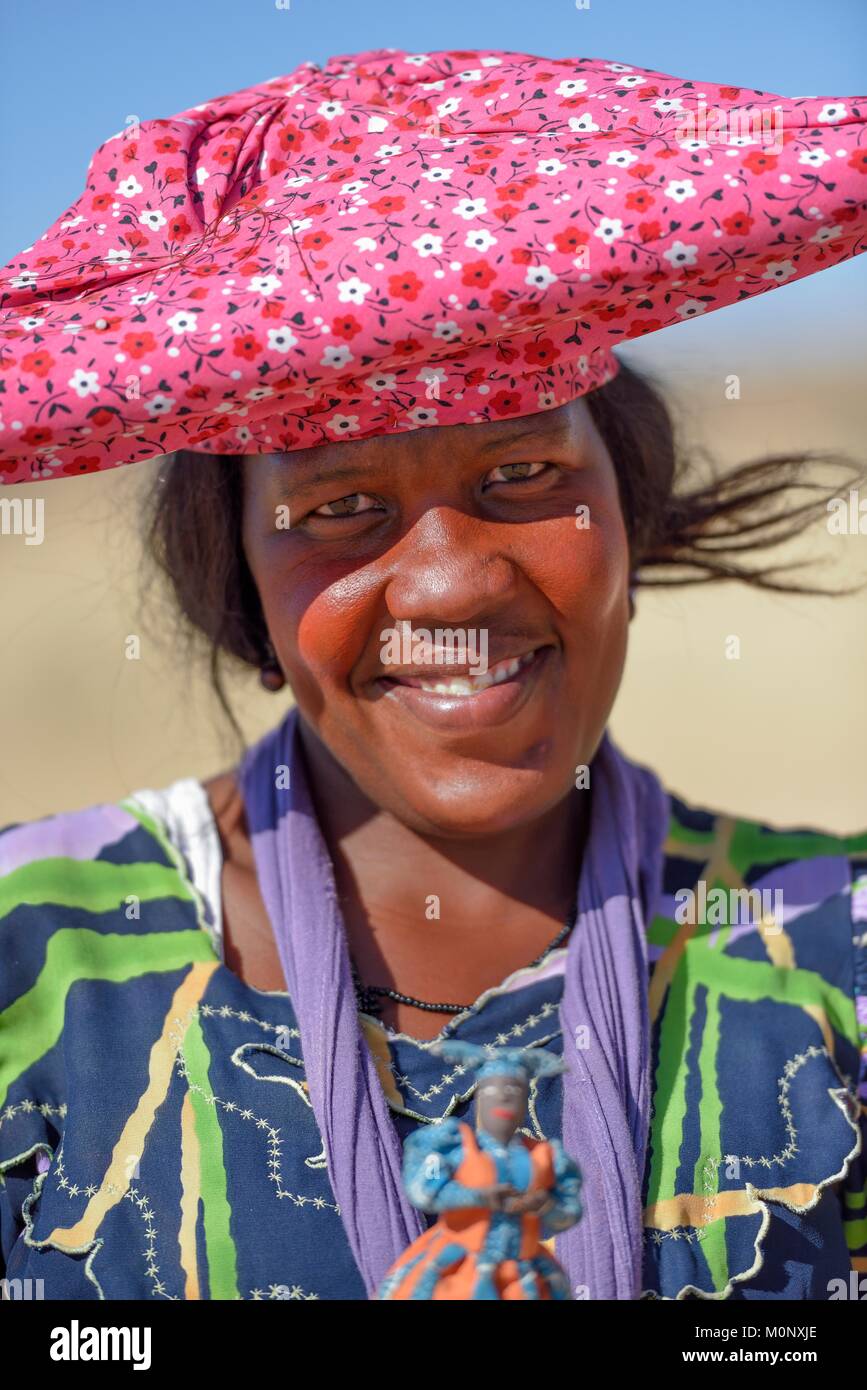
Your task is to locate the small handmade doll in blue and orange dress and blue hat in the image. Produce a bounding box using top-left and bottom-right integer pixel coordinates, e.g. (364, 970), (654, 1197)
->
(378, 1041), (581, 1300)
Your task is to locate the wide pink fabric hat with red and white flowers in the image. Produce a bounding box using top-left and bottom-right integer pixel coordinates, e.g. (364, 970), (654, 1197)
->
(0, 49), (867, 482)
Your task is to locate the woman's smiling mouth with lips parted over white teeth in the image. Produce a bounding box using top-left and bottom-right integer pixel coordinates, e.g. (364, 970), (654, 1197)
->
(375, 646), (553, 730)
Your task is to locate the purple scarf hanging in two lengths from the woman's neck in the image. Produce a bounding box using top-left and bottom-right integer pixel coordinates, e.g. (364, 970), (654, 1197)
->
(240, 709), (668, 1298)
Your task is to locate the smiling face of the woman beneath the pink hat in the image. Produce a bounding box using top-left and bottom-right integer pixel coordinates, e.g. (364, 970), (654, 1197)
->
(243, 400), (629, 837)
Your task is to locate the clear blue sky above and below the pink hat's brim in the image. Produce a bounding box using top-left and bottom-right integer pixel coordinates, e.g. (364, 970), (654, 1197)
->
(0, 0), (867, 361)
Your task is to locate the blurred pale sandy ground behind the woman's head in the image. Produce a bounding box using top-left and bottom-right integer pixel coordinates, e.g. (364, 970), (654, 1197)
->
(0, 337), (867, 833)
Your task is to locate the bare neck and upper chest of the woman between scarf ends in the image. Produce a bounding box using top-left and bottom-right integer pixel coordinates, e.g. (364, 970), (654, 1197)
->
(295, 724), (589, 1038)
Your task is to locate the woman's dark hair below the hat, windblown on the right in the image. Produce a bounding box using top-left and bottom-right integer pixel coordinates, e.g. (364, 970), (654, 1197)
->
(138, 361), (864, 741)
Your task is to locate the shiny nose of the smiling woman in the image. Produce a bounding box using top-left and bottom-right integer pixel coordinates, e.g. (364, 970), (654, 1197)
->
(385, 507), (518, 623)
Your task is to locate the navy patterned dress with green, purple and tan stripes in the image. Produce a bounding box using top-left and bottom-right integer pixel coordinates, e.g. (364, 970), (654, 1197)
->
(0, 780), (867, 1301)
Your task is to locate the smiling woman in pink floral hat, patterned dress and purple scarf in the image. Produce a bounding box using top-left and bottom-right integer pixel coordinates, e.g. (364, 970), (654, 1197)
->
(0, 50), (867, 1298)
